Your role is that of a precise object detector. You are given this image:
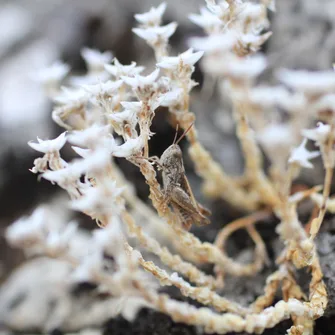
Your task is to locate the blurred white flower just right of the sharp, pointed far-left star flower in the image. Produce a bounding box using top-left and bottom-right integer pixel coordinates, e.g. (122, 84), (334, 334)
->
(68, 125), (111, 148)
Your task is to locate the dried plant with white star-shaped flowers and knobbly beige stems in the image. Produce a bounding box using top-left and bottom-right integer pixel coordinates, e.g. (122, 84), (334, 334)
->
(3, 0), (335, 335)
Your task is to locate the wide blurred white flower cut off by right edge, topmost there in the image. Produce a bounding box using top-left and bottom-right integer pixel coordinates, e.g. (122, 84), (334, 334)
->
(277, 69), (335, 94)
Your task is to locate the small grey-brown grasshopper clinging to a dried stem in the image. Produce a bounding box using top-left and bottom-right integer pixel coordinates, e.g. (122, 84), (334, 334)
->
(155, 123), (211, 230)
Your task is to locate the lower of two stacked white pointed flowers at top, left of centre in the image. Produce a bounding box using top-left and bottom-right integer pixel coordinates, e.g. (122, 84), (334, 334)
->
(132, 22), (177, 46)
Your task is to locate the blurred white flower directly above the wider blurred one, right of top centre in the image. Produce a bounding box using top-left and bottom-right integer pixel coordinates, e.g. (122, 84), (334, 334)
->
(189, 32), (237, 53)
